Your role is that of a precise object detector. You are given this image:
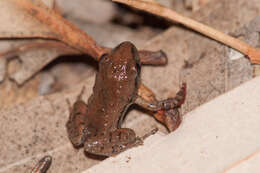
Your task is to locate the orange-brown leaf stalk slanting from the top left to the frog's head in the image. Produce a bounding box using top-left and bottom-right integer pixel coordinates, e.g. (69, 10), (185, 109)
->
(12, 0), (104, 59)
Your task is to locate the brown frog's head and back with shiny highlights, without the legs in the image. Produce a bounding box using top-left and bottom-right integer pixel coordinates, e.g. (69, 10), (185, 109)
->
(87, 42), (140, 130)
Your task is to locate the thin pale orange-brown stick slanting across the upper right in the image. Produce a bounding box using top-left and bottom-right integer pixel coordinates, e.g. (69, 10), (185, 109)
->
(113, 0), (260, 64)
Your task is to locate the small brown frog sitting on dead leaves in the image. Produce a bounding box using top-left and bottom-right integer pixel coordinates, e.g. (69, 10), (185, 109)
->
(66, 42), (186, 156)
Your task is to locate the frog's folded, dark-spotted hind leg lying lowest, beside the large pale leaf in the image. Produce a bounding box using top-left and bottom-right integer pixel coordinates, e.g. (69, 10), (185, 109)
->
(84, 128), (143, 156)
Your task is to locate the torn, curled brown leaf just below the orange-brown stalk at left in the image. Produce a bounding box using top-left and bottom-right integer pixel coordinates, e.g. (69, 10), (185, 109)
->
(7, 41), (80, 85)
